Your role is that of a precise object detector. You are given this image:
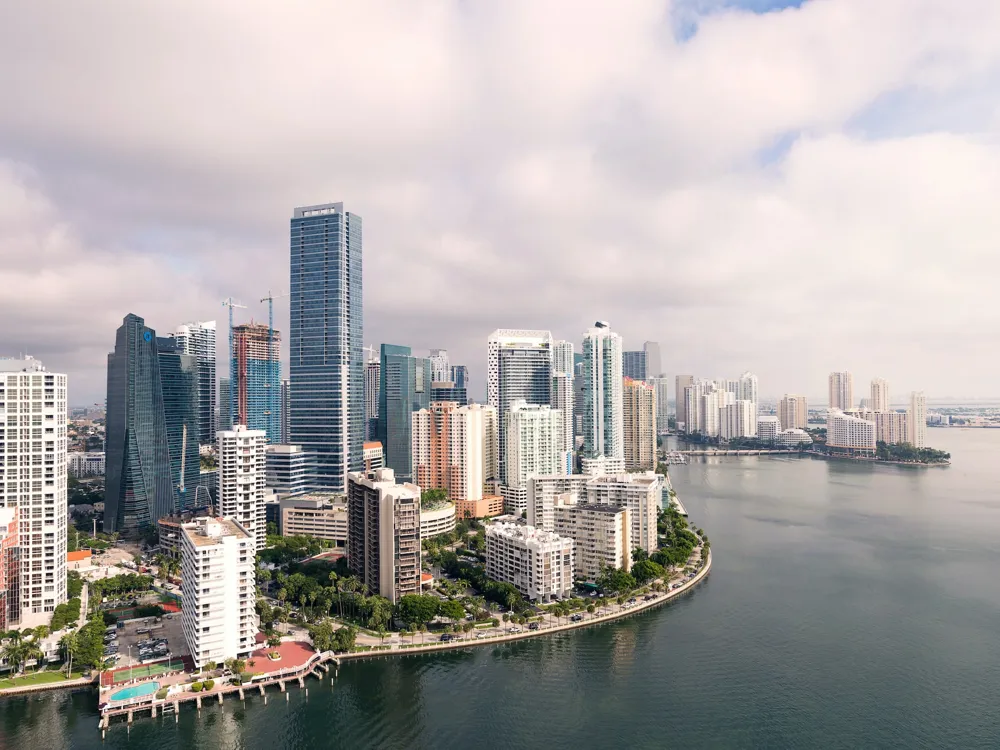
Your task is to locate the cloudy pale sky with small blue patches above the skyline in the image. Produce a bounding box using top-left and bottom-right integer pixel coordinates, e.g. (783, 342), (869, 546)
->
(0, 0), (1000, 404)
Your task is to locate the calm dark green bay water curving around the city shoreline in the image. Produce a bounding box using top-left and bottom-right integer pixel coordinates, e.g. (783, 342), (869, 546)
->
(0, 430), (1000, 750)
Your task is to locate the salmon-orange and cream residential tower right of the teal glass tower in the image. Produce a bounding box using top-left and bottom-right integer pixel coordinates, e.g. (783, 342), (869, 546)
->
(413, 401), (493, 503)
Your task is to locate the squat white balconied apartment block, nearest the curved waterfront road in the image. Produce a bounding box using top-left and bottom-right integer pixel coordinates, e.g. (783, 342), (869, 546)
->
(486, 523), (574, 602)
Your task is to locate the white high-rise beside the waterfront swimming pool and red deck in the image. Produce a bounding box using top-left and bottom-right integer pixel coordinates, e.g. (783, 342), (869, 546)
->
(180, 518), (257, 669)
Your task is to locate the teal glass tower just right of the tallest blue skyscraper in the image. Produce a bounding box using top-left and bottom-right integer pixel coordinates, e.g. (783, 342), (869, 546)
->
(378, 344), (431, 482)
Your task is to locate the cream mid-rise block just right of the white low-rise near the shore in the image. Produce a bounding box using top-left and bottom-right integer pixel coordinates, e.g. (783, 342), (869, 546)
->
(554, 506), (632, 582)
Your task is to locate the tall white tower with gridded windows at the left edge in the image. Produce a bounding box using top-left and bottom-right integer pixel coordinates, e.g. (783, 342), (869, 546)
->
(0, 357), (68, 627)
